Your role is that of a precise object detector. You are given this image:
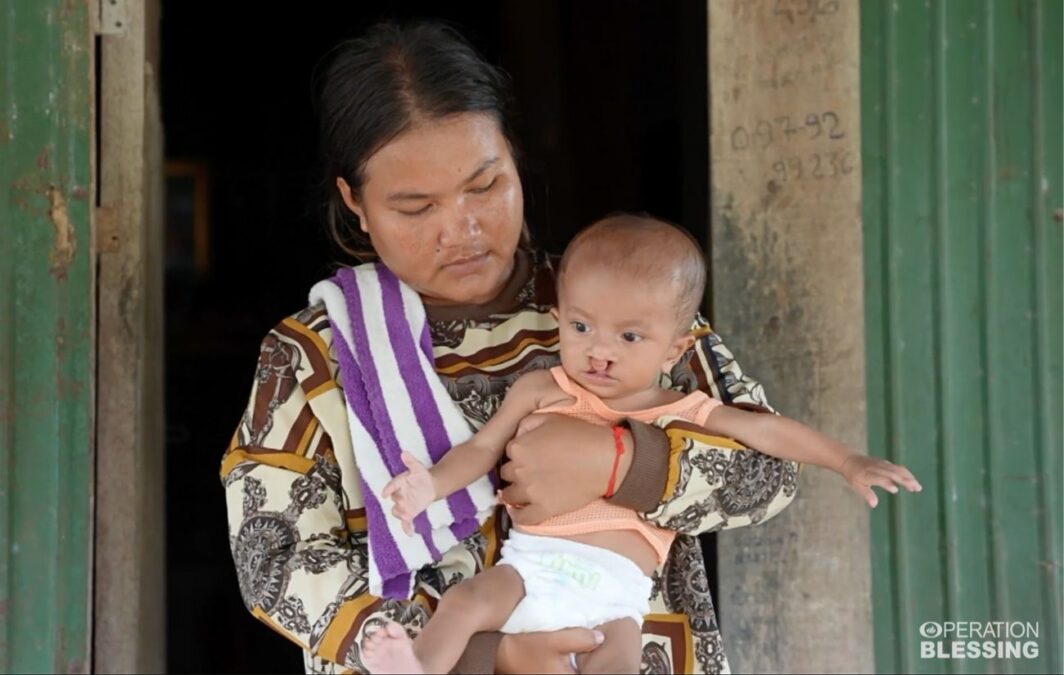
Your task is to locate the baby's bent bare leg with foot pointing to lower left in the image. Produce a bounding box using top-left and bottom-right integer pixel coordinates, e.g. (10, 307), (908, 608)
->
(362, 565), (525, 673)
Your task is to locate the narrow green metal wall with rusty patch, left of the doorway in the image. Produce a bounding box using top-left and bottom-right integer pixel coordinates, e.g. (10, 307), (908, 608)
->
(0, 0), (95, 673)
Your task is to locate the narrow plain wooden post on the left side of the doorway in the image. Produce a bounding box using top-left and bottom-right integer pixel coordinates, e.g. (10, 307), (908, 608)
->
(94, 0), (165, 673)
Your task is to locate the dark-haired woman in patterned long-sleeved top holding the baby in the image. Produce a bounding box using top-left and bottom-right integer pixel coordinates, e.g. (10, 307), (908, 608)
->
(221, 24), (797, 673)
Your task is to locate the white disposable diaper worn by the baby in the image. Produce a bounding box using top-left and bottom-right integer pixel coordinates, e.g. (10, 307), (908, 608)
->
(499, 529), (652, 632)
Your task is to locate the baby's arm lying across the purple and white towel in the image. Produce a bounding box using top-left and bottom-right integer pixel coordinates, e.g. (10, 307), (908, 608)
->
(381, 371), (558, 533)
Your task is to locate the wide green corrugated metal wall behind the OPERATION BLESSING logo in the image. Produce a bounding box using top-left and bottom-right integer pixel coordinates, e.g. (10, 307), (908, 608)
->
(861, 0), (1064, 673)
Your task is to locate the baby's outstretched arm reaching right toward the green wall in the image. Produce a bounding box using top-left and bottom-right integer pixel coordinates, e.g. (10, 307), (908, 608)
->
(705, 406), (922, 507)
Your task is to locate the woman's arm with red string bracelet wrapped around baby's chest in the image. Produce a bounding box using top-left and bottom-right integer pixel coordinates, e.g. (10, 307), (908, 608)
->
(500, 318), (798, 534)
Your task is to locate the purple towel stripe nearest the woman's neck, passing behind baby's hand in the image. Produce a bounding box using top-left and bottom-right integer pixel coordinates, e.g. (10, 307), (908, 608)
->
(377, 265), (477, 528)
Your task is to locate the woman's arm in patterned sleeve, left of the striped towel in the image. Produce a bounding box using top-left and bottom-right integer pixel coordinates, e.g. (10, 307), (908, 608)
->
(221, 313), (495, 669)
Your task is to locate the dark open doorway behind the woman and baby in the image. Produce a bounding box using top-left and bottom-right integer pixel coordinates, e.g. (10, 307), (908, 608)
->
(160, 0), (718, 673)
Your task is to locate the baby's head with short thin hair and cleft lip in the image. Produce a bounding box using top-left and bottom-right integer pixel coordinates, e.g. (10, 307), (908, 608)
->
(556, 214), (705, 398)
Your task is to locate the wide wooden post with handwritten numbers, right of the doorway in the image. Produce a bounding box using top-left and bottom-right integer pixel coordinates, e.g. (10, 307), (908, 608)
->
(709, 0), (872, 673)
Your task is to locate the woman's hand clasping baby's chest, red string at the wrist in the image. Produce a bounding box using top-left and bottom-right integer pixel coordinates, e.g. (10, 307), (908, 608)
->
(499, 414), (632, 525)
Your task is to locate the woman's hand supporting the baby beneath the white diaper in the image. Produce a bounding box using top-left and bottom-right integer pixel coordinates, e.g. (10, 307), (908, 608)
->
(495, 628), (602, 674)
